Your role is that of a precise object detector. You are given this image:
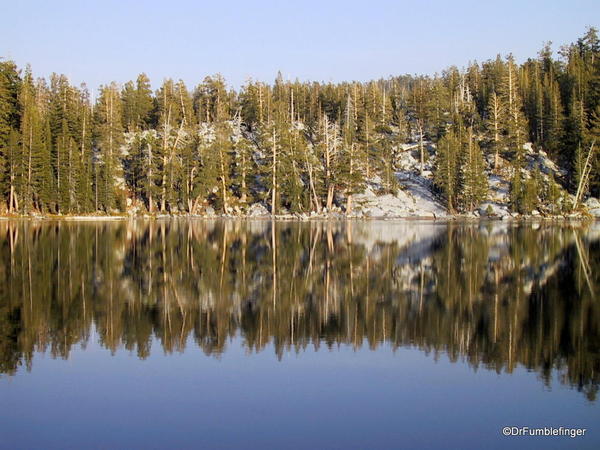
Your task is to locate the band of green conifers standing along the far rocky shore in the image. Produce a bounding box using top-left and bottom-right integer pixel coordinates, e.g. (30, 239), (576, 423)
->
(0, 28), (600, 214)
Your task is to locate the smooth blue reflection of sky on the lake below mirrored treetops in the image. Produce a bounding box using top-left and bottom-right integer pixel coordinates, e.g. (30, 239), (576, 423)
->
(0, 338), (600, 449)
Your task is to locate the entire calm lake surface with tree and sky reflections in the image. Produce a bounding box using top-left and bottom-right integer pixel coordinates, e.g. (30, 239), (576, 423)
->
(0, 220), (600, 449)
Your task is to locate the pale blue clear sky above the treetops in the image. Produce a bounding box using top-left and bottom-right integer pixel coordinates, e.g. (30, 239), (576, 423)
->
(0, 0), (600, 90)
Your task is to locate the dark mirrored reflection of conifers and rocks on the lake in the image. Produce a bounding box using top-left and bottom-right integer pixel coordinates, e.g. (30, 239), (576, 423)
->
(0, 220), (600, 401)
